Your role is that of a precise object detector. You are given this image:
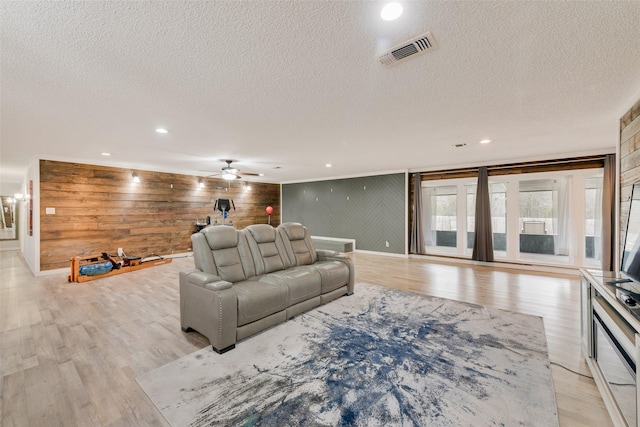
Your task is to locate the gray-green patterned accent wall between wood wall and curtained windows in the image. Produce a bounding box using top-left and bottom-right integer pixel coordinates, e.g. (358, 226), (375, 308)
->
(282, 173), (407, 254)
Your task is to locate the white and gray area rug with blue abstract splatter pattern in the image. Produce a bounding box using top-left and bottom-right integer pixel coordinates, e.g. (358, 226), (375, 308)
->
(137, 284), (558, 427)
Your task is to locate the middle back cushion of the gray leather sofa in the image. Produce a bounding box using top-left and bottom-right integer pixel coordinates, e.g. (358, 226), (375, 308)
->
(243, 224), (291, 275)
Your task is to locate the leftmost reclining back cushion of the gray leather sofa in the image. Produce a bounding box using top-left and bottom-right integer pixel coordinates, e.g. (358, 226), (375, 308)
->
(191, 225), (255, 282)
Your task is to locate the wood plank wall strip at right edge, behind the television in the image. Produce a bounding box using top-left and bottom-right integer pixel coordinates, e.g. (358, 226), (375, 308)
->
(619, 100), (640, 256)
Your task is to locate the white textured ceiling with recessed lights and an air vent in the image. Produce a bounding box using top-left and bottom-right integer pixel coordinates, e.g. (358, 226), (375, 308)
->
(0, 0), (640, 182)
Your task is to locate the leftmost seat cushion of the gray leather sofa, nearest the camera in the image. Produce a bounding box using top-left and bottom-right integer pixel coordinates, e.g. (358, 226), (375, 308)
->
(233, 280), (289, 326)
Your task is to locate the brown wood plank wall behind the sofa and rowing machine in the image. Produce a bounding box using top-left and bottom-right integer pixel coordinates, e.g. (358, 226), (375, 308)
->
(40, 160), (280, 271)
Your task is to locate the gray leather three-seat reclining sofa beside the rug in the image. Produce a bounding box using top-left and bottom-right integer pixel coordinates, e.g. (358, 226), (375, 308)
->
(180, 223), (354, 353)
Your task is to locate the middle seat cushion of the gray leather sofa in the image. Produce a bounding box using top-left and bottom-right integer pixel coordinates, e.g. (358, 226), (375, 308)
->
(260, 266), (322, 307)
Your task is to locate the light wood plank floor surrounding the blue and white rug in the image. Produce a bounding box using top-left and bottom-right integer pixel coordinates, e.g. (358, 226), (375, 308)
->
(0, 252), (612, 427)
